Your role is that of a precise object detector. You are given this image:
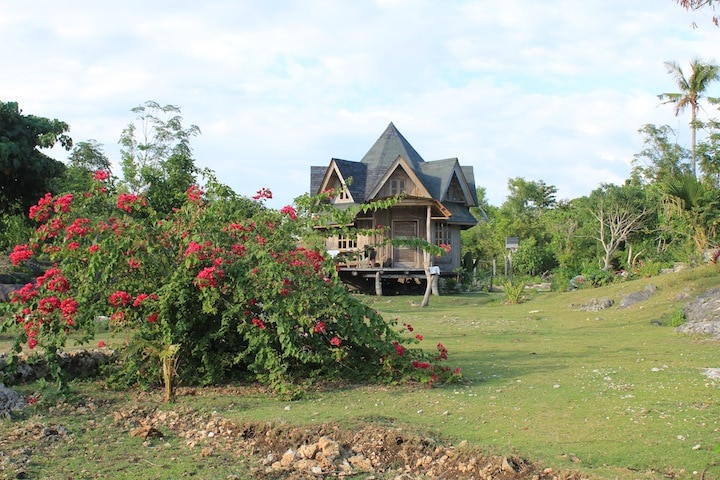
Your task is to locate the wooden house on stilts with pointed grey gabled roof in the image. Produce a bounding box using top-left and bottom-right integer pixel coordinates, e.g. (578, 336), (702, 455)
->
(310, 123), (478, 294)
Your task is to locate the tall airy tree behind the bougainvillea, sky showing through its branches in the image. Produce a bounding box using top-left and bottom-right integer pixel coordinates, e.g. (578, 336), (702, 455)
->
(119, 101), (201, 213)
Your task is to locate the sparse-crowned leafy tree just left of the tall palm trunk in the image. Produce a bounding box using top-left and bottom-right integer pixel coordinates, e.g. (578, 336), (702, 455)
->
(631, 124), (690, 183)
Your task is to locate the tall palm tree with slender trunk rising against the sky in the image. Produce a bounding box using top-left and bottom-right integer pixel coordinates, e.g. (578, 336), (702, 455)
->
(658, 58), (720, 176)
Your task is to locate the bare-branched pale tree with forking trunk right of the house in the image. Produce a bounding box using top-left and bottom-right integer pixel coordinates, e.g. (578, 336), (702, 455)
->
(588, 184), (649, 270)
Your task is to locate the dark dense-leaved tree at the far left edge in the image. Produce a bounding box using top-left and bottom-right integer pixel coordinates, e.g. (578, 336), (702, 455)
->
(0, 102), (72, 212)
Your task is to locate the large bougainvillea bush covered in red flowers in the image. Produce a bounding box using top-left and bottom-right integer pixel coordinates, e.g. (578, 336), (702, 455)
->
(1, 172), (459, 400)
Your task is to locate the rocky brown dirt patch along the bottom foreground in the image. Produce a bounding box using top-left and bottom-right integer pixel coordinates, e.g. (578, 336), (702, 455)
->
(104, 394), (583, 480)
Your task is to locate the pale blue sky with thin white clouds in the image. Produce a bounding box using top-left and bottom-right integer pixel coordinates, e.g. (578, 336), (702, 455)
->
(0, 0), (720, 208)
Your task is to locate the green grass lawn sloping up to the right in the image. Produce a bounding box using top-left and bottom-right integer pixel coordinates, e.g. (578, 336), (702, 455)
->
(0, 267), (720, 480)
